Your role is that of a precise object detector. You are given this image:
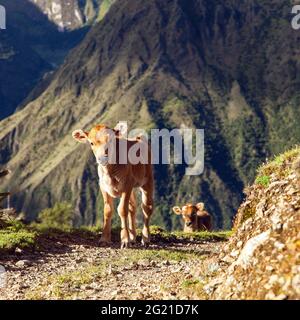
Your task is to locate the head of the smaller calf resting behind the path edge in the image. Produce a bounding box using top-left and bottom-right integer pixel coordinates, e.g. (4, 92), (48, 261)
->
(173, 202), (204, 229)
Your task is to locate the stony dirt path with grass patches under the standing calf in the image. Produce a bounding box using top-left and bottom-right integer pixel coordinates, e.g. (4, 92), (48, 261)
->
(0, 232), (221, 300)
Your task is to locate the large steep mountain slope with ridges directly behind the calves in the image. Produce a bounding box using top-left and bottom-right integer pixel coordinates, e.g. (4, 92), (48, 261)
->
(0, 0), (300, 227)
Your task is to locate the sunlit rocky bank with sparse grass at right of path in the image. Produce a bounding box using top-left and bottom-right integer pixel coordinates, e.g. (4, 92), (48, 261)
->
(204, 147), (300, 300)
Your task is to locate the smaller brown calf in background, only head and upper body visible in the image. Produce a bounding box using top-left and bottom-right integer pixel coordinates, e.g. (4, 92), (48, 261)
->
(173, 202), (212, 232)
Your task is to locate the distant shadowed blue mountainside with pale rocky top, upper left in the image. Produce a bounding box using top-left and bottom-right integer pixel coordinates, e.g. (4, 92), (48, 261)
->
(0, 0), (112, 119)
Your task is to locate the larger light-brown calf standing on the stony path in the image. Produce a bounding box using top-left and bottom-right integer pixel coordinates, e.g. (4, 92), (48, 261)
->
(72, 125), (153, 248)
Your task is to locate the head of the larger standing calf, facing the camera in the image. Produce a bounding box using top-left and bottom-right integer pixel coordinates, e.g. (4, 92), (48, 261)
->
(72, 124), (127, 166)
